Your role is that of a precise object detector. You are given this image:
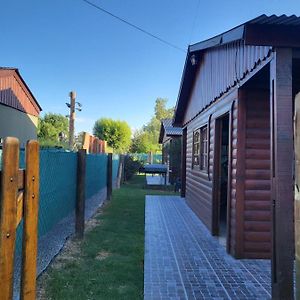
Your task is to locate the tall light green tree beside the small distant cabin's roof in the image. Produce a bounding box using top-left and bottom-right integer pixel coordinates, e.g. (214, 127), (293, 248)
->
(130, 98), (174, 153)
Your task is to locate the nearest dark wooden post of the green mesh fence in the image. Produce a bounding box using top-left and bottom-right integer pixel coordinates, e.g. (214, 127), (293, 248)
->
(75, 149), (86, 238)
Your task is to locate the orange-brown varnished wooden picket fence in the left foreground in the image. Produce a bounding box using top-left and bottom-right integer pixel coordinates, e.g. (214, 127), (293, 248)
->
(0, 138), (39, 300)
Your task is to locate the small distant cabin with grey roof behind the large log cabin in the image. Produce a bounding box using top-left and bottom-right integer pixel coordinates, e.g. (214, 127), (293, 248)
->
(158, 119), (182, 184)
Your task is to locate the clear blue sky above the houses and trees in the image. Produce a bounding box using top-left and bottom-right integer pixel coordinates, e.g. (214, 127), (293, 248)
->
(0, 0), (300, 132)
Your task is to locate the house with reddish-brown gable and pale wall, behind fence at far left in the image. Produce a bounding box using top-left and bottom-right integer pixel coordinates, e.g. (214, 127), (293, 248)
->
(0, 67), (42, 147)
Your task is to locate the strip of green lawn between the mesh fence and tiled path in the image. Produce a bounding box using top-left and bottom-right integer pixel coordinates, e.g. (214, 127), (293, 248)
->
(39, 176), (176, 300)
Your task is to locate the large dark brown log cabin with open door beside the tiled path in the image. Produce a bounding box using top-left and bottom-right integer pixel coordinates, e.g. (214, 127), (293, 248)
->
(173, 15), (300, 262)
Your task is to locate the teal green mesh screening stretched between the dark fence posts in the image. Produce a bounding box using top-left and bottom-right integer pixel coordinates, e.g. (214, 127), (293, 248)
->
(0, 149), (112, 255)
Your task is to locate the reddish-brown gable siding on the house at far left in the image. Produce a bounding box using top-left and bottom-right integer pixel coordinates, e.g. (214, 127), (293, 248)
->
(0, 70), (40, 116)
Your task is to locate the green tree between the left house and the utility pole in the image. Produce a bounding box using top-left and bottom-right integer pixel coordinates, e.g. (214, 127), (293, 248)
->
(38, 113), (69, 146)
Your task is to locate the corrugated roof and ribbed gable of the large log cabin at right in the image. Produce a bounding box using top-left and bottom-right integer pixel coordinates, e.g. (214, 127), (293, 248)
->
(173, 15), (300, 126)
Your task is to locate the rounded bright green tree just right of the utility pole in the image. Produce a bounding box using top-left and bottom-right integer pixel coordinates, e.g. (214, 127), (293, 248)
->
(93, 118), (131, 153)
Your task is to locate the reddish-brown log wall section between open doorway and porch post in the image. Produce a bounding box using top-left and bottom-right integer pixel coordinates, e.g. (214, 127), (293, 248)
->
(230, 88), (271, 258)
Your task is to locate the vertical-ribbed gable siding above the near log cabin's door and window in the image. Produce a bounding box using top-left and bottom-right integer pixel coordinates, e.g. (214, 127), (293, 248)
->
(183, 41), (271, 124)
